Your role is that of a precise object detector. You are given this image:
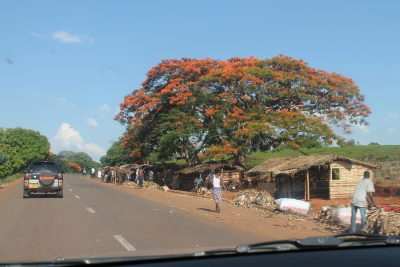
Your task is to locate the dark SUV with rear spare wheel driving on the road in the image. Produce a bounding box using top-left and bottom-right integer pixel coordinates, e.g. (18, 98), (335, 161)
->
(23, 161), (64, 198)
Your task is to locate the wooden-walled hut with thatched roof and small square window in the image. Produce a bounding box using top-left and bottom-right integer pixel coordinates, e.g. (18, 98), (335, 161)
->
(249, 155), (378, 199)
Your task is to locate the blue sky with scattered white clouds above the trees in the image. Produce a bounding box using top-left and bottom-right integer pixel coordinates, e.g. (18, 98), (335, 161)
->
(0, 0), (400, 161)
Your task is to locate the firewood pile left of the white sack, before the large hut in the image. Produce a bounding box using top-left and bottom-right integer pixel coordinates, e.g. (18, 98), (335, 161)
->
(234, 189), (275, 208)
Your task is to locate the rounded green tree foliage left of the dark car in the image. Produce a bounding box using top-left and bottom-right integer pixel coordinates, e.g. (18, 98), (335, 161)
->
(0, 128), (50, 177)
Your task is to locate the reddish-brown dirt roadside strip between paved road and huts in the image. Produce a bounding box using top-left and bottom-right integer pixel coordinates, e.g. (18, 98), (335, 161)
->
(86, 178), (348, 240)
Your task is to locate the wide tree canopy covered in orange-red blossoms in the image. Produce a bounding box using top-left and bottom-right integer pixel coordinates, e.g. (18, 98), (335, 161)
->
(116, 55), (371, 166)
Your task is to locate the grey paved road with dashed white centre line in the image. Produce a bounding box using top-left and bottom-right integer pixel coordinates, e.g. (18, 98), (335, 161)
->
(0, 175), (266, 262)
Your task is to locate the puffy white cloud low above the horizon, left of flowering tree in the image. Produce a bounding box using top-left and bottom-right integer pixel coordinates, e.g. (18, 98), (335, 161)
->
(50, 123), (106, 158)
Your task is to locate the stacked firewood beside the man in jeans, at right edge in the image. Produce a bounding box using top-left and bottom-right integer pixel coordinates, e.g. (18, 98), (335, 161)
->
(364, 205), (400, 235)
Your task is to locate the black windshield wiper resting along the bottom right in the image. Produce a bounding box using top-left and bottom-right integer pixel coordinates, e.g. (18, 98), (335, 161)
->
(194, 233), (400, 256)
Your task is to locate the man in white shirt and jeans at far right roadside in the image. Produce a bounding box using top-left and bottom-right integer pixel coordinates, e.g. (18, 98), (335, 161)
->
(350, 171), (376, 233)
